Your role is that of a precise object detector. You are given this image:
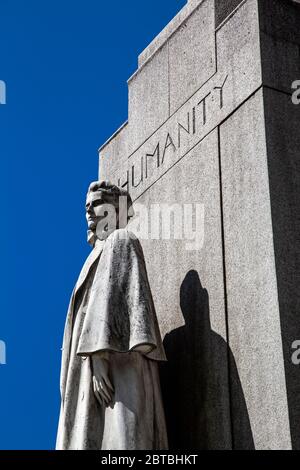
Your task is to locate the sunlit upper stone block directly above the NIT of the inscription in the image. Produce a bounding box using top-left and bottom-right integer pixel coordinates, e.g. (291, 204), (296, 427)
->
(169, 1), (216, 113)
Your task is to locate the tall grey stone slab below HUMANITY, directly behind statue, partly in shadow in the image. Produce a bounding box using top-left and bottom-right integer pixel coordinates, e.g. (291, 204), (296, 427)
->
(127, 131), (233, 449)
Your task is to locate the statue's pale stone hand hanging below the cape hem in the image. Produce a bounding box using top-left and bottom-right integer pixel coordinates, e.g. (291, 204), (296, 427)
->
(92, 354), (114, 406)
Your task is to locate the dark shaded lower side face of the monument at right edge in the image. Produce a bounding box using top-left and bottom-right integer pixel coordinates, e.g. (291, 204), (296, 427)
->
(264, 89), (300, 449)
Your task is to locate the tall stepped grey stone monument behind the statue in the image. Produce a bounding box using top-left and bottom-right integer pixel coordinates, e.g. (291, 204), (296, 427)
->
(100, 0), (300, 449)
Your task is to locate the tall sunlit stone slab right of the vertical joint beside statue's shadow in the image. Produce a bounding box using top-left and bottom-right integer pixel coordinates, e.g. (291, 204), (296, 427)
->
(220, 90), (291, 449)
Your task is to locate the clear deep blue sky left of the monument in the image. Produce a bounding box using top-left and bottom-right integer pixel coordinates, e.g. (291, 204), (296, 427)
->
(0, 0), (186, 449)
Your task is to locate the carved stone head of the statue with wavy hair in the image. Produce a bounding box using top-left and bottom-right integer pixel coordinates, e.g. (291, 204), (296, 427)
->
(86, 181), (134, 245)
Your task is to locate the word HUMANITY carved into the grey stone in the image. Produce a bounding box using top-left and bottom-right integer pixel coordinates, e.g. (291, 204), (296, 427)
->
(115, 75), (228, 199)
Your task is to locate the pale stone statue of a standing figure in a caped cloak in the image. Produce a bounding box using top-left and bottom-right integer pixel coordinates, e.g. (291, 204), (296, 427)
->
(56, 181), (168, 450)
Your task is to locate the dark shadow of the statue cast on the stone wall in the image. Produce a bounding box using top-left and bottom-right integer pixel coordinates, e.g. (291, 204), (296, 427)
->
(160, 271), (254, 450)
